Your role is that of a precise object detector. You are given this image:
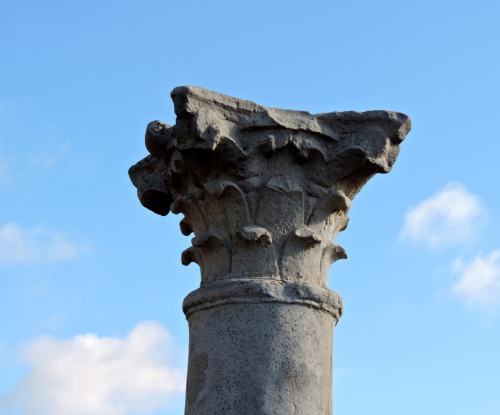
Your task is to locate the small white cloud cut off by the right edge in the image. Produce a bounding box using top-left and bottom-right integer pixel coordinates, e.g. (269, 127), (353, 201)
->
(452, 250), (500, 308)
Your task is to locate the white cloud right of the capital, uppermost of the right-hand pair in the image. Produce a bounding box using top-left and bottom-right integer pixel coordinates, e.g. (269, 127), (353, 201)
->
(401, 183), (483, 248)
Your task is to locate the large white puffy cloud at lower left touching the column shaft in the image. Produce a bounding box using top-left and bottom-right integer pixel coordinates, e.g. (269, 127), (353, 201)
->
(0, 322), (185, 415)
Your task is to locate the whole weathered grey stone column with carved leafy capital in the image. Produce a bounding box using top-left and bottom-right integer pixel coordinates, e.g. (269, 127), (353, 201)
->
(130, 87), (410, 415)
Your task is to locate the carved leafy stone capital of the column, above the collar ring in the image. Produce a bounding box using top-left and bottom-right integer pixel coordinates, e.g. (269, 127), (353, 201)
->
(130, 87), (410, 287)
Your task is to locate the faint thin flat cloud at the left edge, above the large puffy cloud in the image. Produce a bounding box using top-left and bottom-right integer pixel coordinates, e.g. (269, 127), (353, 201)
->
(0, 223), (87, 264)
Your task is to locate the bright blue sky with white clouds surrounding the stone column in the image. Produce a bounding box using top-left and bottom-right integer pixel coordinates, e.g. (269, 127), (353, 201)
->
(0, 0), (500, 415)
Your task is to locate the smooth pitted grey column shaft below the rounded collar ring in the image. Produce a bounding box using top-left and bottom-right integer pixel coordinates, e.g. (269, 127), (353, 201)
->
(185, 303), (336, 415)
